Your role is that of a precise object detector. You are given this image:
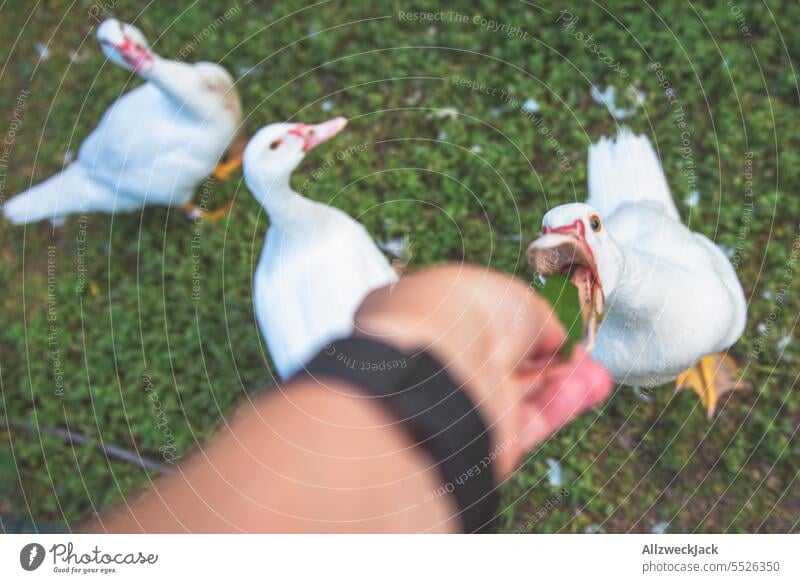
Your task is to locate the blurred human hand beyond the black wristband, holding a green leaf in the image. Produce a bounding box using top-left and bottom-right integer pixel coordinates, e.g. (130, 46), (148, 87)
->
(355, 264), (612, 479)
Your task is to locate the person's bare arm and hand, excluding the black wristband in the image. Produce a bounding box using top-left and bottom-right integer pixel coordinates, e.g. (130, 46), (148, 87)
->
(91, 265), (611, 532)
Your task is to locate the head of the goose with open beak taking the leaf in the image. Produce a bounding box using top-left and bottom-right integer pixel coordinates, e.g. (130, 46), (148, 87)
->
(528, 203), (621, 350)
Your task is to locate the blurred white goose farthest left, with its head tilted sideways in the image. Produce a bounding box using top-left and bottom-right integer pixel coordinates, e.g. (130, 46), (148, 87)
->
(3, 19), (242, 224)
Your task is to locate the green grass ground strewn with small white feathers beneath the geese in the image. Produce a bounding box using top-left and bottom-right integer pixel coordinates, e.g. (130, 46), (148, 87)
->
(0, 0), (800, 532)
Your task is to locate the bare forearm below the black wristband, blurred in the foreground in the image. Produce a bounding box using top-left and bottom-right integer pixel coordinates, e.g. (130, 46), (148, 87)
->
(92, 381), (459, 532)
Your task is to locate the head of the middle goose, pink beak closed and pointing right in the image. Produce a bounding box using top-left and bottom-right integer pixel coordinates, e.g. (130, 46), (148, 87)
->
(242, 117), (347, 195)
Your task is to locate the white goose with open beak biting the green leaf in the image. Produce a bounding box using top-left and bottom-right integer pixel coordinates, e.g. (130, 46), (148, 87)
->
(528, 130), (747, 416)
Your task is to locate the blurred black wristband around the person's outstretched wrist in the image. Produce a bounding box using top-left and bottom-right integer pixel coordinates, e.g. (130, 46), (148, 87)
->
(294, 337), (498, 532)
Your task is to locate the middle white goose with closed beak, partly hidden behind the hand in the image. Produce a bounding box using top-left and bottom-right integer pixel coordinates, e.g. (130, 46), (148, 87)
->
(244, 117), (397, 379)
